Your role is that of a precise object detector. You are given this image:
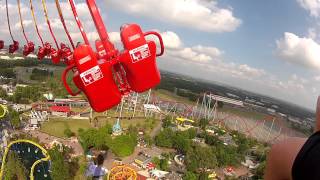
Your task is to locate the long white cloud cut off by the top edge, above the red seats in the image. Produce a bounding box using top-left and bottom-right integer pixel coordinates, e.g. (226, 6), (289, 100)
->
(106, 0), (241, 32)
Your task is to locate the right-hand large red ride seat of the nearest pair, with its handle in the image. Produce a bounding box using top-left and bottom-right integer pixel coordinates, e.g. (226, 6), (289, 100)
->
(119, 24), (164, 92)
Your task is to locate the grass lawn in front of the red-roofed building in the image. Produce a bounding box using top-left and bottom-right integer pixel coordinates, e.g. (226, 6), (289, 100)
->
(40, 118), (92, 137)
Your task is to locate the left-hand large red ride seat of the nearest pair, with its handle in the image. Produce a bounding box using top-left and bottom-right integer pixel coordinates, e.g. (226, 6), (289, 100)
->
(62, 45), (121, 112)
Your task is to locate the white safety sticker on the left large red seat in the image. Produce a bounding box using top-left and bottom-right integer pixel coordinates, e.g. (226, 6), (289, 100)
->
(80, 65), (103, 86)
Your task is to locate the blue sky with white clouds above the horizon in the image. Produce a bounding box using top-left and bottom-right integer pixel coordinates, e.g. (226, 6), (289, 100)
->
(0, 0), (320, 109)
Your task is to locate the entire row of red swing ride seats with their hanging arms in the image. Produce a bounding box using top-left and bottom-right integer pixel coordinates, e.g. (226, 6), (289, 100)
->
(2, 0), (164, 112)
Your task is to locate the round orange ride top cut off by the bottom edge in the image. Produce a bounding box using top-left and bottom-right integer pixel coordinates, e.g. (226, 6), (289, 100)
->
(108, 165), (137, 180)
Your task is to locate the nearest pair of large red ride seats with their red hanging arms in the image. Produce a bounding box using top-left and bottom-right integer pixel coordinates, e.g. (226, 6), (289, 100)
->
(62, 0), (164, 112)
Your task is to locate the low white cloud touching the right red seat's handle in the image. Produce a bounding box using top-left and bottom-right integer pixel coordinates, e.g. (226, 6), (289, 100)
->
(159, 32), (266, 80)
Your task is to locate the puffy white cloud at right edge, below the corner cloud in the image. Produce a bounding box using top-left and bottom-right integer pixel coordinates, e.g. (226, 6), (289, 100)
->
(276, 32), (320, 69)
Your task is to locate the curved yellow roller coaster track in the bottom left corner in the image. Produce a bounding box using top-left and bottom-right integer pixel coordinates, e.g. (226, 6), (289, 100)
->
(0, 139), (50, 180)
